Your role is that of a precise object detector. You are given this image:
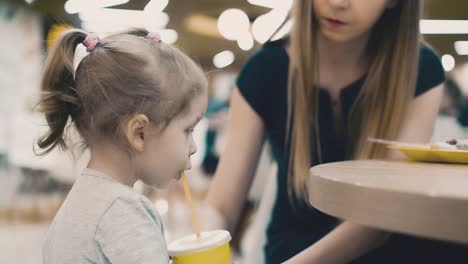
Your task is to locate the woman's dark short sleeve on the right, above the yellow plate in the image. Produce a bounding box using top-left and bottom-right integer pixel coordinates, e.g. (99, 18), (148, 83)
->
(416, 44), (445, 96)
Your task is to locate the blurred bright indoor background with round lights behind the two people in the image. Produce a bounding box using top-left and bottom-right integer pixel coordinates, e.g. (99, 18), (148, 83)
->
(0, 0), (468, 264)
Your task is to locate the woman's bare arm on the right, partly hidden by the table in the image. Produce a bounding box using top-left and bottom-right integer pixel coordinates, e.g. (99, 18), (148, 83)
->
(285, 84), (443, 264)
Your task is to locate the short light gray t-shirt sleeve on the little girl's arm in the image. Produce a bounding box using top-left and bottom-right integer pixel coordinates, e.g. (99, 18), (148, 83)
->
(95, 198), (169, 264)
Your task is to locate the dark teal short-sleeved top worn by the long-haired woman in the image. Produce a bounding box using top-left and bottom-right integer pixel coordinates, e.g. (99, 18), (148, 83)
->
(236, 40), (468, 264)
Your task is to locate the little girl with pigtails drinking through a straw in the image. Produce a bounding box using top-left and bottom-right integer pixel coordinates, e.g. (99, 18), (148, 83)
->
(38, 29), (207, 264)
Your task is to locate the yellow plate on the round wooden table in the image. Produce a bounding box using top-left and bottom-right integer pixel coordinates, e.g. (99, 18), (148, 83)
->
(388, 144), (468, 164)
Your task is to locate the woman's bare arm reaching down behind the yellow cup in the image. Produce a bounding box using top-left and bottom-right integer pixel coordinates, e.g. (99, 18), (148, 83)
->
(201, 88), (265, 231)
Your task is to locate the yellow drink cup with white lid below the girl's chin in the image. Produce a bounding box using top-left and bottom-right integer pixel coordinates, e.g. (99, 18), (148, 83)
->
(168, 230), (232, 264)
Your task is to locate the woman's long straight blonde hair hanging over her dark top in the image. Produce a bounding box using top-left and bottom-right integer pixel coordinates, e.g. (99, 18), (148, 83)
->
(287, 0), (420, 201)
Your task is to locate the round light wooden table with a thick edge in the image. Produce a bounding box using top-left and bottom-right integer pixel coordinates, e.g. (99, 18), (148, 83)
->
(309, 160), (468, 244)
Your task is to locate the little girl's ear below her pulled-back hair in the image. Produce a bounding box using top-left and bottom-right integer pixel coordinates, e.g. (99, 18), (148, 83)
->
(125, 114), (150, 152)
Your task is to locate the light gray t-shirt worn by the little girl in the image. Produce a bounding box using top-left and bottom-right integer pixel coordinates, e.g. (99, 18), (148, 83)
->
(43, 169), (169, 264)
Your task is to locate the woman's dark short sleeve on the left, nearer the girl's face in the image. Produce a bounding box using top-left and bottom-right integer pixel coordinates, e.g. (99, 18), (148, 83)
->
(236, 47), (271, 120)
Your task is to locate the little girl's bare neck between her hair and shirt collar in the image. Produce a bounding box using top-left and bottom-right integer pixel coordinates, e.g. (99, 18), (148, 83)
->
(87, 144), (137, 187)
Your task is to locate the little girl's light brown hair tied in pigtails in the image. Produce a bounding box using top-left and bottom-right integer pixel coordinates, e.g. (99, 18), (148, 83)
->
(37, 29), (207, 155)
